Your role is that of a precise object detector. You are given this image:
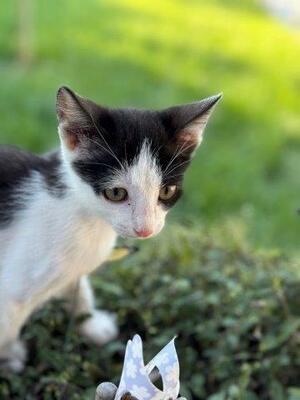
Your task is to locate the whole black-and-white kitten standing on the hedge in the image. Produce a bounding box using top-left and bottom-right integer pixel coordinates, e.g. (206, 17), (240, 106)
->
(0, 87), (221, 371)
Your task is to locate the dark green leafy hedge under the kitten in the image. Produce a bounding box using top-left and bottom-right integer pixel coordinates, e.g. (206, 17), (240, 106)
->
(0, 225), (300, 400)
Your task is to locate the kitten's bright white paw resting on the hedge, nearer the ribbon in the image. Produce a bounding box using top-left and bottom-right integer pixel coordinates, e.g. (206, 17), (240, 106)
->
(80, 310), (119, 346)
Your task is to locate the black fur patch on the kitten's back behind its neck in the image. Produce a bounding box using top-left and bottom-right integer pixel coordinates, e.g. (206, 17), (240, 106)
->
(0, 146), (66, 228)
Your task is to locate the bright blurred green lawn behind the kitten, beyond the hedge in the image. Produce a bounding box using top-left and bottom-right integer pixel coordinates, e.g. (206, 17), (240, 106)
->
(0, 0), (300, 251)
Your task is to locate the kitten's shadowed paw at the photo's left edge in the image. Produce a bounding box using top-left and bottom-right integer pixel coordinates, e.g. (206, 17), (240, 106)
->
(0, 340), (27, 373)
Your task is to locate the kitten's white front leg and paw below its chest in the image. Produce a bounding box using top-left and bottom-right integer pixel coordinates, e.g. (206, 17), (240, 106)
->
(63, 275), (118, 346)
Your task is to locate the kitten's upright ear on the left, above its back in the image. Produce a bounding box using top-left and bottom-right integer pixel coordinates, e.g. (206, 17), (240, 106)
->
(56, 86), (98, 151)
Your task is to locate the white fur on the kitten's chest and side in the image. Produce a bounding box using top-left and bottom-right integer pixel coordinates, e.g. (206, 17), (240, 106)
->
(0, 191), (116, 308)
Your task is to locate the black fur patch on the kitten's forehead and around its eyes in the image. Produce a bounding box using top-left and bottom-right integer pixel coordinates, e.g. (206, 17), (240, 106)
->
(73, 109), (190, 206)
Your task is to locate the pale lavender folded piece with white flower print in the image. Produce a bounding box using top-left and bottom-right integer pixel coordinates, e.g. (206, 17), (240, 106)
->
(115, 335), (180, 400)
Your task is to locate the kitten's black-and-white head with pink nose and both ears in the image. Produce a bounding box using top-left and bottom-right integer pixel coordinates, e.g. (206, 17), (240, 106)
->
(57, 87), (221, 238)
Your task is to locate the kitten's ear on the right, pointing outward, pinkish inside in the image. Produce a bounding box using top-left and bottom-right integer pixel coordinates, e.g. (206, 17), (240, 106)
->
(162, 94), (222, 155)
